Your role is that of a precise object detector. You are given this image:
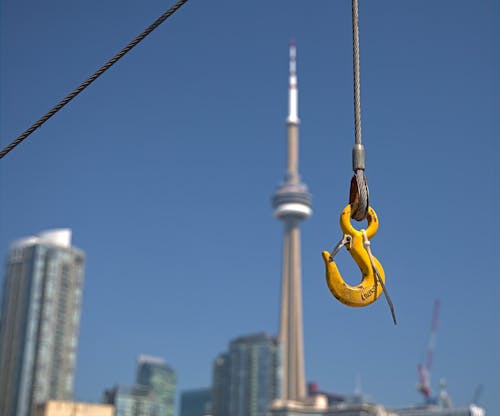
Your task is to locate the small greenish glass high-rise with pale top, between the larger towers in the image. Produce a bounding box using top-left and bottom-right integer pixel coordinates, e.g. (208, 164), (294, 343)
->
(136, 355), (176, 416)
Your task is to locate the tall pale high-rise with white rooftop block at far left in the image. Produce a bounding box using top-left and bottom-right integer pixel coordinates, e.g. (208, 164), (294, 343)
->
(0, 229), (85, 416)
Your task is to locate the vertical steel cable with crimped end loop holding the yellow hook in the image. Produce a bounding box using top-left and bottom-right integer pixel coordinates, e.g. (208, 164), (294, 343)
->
(349, 0), (369, 221)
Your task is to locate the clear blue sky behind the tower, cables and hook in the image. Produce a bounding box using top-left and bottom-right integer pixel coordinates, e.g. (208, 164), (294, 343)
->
(0, 0), (500, 415)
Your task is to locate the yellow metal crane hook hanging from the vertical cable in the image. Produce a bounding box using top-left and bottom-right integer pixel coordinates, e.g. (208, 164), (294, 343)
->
(322, 204), (385, 307)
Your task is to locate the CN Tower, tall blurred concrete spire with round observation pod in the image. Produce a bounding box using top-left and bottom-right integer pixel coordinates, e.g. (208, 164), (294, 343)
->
(273, 42), (312, 403)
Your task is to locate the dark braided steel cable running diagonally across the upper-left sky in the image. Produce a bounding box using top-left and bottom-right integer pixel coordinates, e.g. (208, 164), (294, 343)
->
(0, 0), (188, 159)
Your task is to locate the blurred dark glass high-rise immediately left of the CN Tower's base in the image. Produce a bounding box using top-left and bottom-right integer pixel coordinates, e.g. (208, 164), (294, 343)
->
(212, 333), (280, 416)
